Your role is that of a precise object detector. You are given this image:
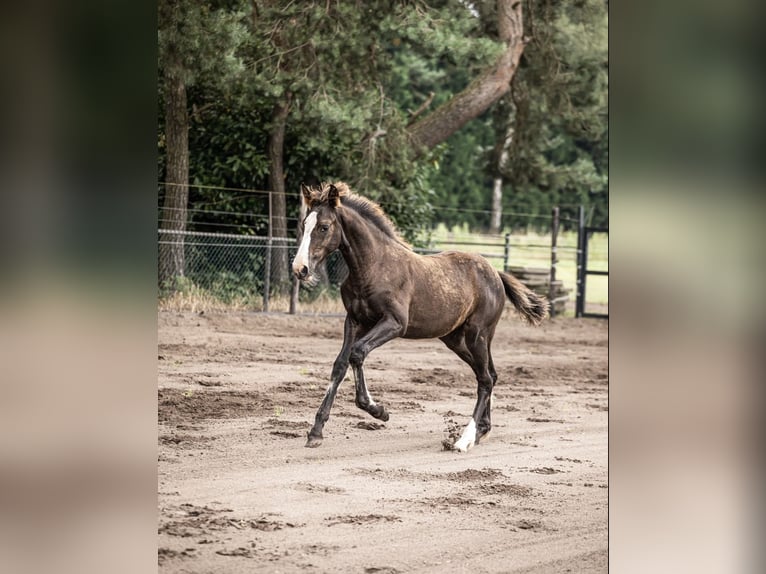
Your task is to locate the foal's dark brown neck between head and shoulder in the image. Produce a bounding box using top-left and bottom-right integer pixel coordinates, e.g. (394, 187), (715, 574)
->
(340, 209), (398, 278)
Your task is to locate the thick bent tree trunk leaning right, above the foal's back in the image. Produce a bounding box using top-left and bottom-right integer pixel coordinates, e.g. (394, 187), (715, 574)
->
(409, 0), (526, 153)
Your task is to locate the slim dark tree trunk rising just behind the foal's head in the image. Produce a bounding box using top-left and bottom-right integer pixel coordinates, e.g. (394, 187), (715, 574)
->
(269, 92), (292, 294)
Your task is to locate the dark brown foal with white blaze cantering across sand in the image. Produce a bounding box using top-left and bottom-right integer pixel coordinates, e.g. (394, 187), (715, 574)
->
(292, 182), (549, 452)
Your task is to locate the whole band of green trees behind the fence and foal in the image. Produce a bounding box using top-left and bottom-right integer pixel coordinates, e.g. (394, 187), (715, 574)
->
(158, 0), (608, 287)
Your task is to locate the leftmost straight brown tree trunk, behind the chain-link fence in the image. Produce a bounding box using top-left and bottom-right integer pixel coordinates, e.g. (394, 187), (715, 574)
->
(159, 63), (189, 285)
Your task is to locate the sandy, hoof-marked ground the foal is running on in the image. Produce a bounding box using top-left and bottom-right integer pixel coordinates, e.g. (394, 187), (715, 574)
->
(158, 312), (609, 574)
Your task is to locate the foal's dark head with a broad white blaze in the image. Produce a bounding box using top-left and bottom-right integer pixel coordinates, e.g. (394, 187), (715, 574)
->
(293, 184), (348, 281)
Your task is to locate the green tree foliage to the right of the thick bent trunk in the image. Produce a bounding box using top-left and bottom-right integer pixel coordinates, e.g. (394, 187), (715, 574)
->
(504, 0), (609, 231)
